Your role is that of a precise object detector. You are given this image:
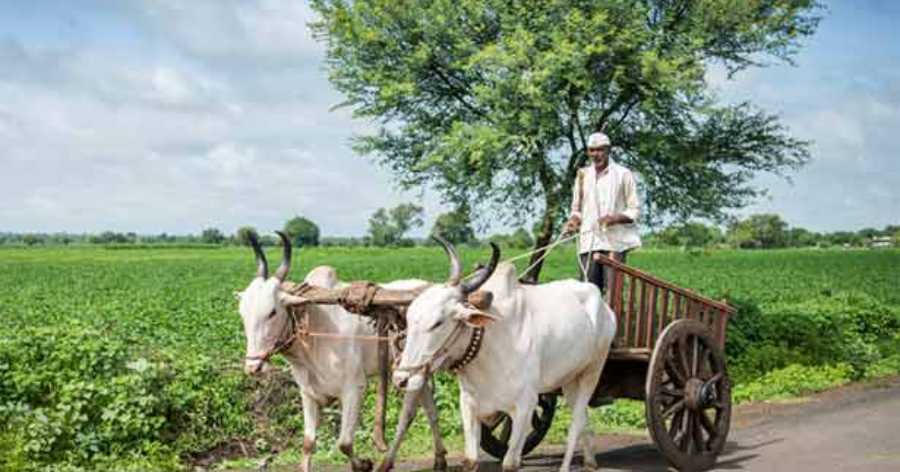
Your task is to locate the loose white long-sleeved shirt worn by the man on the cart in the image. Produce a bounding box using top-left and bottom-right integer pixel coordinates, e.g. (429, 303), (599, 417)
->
(572, 159), (641, 253)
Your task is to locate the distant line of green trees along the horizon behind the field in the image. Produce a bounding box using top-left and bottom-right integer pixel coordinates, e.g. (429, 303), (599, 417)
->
(0, 209), (900, 249)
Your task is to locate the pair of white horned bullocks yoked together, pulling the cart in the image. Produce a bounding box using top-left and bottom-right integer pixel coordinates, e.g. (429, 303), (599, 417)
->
(240, 233), (616, 472)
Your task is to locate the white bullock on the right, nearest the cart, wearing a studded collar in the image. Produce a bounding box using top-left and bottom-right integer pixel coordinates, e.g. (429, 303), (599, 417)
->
(394, 243), (616, 471)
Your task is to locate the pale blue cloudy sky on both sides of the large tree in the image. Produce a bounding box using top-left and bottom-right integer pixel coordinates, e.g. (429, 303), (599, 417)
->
(0, 0), (900, 235)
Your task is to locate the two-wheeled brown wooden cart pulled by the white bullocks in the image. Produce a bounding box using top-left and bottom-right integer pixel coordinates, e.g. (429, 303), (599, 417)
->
(481, 256), (735, 470)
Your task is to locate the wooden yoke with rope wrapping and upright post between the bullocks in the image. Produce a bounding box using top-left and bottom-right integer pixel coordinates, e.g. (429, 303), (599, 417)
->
(281, 280), (422, 452)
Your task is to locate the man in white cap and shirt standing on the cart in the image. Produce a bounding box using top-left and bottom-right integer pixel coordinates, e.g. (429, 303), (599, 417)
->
(565, 133), (641, 294)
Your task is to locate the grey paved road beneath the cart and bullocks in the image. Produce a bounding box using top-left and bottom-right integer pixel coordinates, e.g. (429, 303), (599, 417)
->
(388, 378), (900, 472)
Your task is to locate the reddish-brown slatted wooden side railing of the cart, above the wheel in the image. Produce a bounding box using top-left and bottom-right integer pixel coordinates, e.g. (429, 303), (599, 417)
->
(597, 255), (736, 350)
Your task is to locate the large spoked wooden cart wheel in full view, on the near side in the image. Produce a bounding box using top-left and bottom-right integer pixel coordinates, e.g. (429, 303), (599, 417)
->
(646, 320), (731, 471)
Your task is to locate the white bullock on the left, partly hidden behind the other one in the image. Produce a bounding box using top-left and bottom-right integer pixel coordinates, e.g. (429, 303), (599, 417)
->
(239, 232), (446, 472)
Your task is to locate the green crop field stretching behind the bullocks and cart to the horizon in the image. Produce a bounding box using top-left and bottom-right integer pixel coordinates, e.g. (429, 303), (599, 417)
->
(0, 247), (900, 470)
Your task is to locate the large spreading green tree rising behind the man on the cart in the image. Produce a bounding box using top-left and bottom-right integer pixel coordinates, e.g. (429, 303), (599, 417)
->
(312, 0), (820, 275)
